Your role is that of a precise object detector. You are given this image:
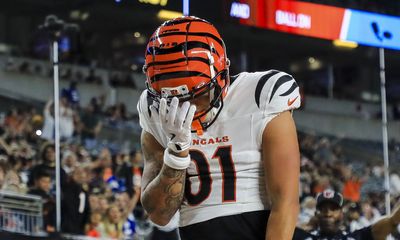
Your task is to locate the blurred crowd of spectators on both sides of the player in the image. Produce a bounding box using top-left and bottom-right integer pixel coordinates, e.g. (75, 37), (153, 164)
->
(0, 94), (400, 239)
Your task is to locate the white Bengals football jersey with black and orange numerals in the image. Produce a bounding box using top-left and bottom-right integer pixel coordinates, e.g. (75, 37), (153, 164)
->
(138, 70), (300, 226)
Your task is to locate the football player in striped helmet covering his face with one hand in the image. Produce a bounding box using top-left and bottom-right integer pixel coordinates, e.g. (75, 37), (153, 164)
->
(138, 17), (300, 240)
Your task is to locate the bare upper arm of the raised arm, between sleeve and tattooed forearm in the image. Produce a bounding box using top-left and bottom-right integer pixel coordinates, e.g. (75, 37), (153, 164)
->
(141, 131), (164, 191)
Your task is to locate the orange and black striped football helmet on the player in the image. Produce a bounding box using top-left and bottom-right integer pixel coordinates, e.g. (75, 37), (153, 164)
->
(143, 16), (229, 132)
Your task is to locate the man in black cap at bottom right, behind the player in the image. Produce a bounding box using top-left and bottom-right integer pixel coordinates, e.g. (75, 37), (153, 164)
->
(293, 189), (400, 240)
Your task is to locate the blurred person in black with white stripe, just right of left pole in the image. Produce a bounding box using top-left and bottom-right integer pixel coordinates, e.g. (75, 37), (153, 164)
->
(61, 168), (90, 235)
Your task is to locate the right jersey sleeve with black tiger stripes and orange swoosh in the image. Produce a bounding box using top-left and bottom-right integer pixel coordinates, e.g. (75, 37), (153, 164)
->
(255, 70), (301, 116)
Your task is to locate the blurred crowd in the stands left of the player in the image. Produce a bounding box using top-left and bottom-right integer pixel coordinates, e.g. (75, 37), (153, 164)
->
(0, 94), (150, 239)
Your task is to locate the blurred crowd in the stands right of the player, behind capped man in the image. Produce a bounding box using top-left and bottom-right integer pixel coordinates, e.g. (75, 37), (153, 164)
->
(298, 131), (400, 232)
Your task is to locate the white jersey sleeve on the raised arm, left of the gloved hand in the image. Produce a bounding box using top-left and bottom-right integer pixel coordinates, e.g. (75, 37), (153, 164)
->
(137, 90), (168, 147)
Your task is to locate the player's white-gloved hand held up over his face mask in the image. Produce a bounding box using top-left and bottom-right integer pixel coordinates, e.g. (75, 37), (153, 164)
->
(151, 97), (196, 153)
